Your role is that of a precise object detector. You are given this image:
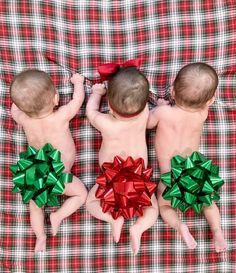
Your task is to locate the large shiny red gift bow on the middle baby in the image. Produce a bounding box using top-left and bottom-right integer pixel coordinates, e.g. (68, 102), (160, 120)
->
(95, 156), (156, 219)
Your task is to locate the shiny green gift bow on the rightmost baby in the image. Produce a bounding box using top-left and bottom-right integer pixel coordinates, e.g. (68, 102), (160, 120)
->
(161, 152), (224, 213)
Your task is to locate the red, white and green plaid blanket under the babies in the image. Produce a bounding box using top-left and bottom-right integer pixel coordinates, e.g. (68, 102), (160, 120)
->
(0, 0), (236, 273)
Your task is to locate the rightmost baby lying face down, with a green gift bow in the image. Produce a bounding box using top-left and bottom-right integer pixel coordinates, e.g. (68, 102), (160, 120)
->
(147, 63), (226, 252)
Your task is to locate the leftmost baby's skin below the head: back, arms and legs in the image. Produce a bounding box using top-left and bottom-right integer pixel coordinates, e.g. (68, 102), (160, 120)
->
(11, 74), (87, 252)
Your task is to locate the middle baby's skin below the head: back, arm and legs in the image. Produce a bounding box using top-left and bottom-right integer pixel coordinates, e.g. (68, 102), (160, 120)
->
(86, 84), (158, 254)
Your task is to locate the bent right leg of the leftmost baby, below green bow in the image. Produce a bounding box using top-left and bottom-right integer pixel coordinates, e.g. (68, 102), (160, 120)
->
(50, 176), (87, 236)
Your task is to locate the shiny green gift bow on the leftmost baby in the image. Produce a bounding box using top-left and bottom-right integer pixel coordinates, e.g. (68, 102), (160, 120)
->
(10, 143), (73, 208)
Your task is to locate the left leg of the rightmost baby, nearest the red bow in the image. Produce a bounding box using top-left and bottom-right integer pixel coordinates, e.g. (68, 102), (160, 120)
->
(158, 182), (197, 249)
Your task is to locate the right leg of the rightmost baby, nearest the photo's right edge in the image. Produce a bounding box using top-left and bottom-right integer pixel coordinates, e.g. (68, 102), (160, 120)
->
(203, 202), (227, 252)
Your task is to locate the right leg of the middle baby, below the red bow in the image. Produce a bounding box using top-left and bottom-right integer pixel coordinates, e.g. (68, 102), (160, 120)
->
(129, 194), (158, 255)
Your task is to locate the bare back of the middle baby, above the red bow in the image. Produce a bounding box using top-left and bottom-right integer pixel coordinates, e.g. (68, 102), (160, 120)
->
(99, 107), (148, 166)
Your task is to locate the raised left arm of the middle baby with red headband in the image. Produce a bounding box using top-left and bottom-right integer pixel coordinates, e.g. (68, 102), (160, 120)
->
(86, 84), (107, 131)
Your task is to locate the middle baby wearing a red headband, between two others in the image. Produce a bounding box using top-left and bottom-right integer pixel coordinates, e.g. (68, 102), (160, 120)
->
(86, 67), (158, 254)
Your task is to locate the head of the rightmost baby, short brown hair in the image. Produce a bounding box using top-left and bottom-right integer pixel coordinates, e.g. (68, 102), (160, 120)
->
(173, 63), (218, 109)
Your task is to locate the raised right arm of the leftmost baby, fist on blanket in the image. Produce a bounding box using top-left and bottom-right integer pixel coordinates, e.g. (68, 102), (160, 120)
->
(58, 73), (85, 120)
